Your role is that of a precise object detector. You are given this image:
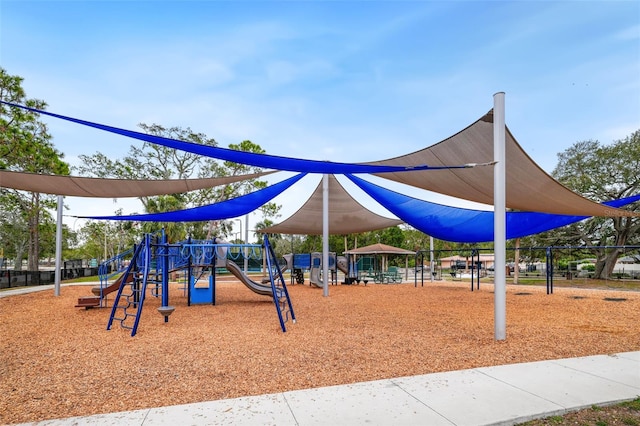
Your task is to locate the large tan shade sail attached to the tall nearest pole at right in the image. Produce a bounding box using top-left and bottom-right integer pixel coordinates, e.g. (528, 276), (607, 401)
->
(367, 110), (638, 216)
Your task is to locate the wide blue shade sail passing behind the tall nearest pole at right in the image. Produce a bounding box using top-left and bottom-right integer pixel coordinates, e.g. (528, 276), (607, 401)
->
(347, 175), (640, 243)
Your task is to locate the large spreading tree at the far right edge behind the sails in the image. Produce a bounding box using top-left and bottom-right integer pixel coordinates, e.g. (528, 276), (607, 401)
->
(549, 130), (640, 278)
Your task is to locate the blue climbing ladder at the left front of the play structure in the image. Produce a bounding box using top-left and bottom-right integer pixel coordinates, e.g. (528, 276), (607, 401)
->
(107, 234), (152, 337)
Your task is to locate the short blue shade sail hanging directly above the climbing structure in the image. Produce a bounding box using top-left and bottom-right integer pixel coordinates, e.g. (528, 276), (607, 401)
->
(78, 173), (305, 222)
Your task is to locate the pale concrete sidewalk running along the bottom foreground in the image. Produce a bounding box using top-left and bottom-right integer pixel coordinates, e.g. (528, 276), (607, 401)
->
(20, 351), (640, 426)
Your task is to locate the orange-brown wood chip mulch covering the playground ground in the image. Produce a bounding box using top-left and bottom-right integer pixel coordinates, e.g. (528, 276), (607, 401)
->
(0, 282), (640, 424)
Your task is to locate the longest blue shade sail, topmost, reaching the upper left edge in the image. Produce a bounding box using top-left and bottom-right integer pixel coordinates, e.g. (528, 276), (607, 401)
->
(0, 101), (476, 174)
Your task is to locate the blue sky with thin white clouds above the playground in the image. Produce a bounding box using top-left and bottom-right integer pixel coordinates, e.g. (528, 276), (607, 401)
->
(0, 0), (640, 238)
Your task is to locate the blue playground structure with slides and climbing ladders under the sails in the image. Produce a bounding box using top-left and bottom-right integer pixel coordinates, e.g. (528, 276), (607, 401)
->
(76, 232), (295, 336)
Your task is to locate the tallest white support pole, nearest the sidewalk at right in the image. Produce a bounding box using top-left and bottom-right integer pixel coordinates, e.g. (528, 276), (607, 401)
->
(493, 92), (507, 340)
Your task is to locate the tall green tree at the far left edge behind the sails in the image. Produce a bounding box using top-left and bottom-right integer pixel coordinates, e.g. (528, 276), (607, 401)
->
(0, 68), (69, 271)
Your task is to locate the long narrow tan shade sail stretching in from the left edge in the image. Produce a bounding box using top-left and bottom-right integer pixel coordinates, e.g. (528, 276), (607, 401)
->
(0, 170), (274, 198)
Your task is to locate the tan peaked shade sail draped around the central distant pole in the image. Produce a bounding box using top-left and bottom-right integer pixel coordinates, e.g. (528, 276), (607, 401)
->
(261, 175), (403, 235)
